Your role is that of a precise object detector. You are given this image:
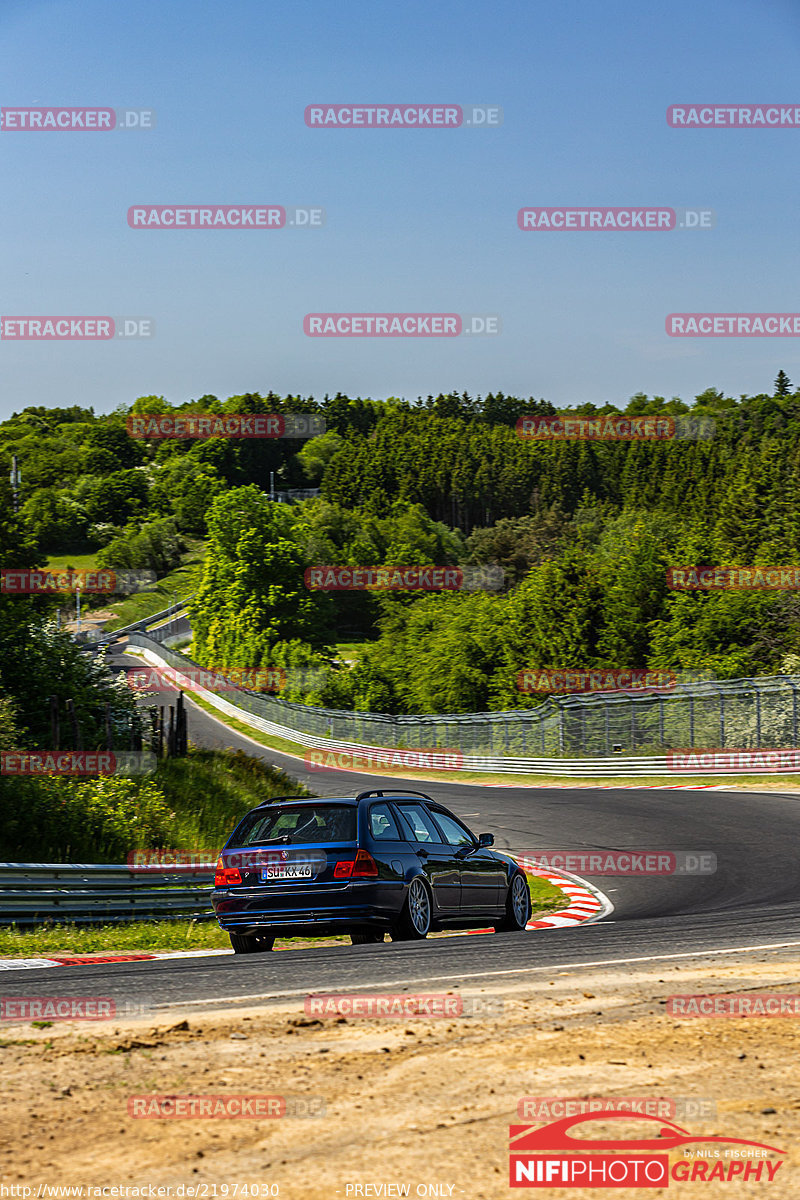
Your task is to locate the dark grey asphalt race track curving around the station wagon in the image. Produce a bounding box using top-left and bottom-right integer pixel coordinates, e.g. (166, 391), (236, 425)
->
(9, 654), (800, 1010)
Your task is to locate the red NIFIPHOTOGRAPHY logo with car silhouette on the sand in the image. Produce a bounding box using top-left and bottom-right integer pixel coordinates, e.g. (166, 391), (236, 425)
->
(509, 1110), (786, 1188)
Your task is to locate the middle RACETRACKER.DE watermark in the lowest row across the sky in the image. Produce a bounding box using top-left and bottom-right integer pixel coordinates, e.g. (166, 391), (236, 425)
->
(302, 312), (503, 337)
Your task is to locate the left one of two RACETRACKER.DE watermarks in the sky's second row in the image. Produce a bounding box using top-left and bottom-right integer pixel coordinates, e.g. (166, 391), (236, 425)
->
(127, 204), (326, 229)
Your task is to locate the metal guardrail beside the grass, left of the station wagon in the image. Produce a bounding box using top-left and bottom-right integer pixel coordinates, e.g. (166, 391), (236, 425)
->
(0, 863), (213, 925)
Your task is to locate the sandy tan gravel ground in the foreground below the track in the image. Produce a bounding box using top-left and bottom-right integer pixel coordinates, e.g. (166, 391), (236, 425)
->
(0, 954), (800, 1200)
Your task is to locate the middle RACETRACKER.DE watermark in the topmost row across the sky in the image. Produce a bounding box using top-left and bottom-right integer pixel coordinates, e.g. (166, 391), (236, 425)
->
(303, 103), (503, 130)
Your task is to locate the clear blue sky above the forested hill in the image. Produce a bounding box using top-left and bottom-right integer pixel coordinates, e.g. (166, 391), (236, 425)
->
(0, 0), (800, 416)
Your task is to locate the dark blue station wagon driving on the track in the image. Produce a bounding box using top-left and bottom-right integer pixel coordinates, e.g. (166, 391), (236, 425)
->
(211, 791), (530, 954)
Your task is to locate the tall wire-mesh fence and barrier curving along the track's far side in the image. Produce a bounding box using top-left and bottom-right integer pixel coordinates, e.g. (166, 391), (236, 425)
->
(128, 634), (800, 774)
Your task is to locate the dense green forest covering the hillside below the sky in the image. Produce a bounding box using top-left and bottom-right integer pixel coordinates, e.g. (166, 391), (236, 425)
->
(0, 372), (800, 713)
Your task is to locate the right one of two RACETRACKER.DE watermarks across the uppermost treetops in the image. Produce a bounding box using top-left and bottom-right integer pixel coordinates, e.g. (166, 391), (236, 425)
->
(517, 413), (716, 442)
